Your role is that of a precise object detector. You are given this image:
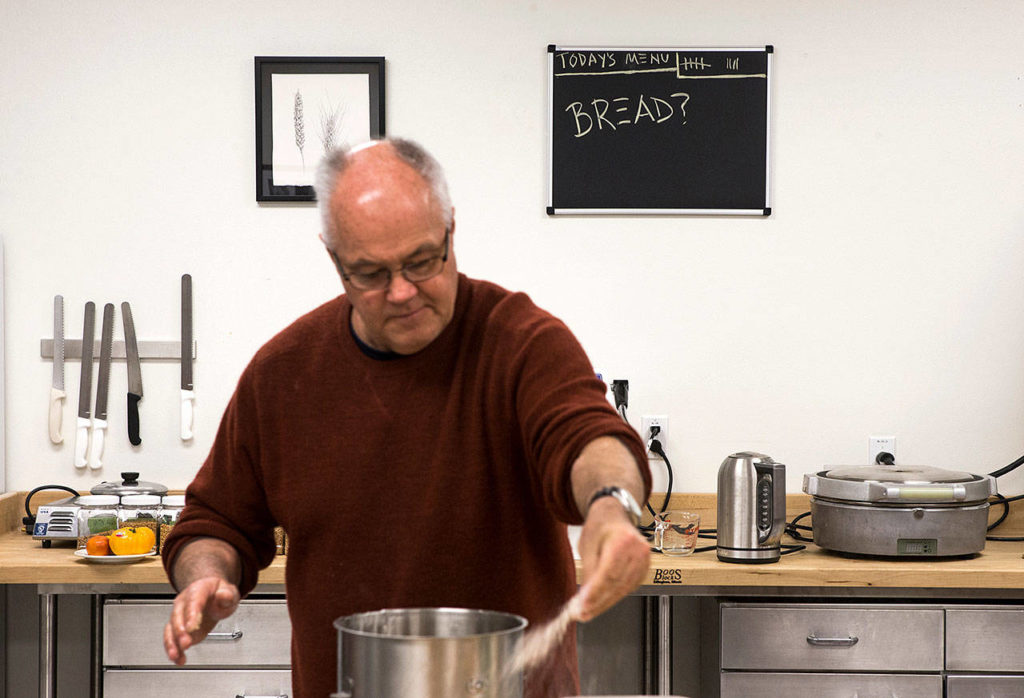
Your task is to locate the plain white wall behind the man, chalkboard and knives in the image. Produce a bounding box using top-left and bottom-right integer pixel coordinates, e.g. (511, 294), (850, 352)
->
(0, 0), (1024, 493)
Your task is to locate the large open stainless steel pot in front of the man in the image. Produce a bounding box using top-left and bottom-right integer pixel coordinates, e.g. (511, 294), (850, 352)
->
(332, 608), (526, 698)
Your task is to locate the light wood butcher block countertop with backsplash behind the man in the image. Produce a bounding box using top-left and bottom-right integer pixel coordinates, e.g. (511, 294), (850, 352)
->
(0, 492), (1024, 594)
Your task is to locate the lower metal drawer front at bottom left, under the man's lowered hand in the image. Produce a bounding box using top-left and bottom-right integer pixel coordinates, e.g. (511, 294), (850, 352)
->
(103, 669), (292, 698)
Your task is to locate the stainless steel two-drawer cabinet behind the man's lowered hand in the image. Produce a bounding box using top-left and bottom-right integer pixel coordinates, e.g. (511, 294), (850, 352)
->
(102, 598), (292, 698)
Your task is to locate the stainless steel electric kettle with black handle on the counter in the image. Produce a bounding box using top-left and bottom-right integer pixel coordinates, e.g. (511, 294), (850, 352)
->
(718, 451), (785, 563)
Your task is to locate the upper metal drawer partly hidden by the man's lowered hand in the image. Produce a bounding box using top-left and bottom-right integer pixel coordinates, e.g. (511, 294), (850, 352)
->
(103, 599), (292, 666)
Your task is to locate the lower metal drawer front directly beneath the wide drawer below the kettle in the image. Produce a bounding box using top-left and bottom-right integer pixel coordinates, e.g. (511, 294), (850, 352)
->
(721, 671), (942, 698)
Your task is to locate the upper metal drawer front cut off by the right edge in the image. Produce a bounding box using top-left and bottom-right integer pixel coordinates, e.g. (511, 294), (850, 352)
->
(946, 608), (1024, 671)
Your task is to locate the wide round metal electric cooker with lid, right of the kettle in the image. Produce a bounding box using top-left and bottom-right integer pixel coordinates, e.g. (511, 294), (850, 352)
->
(804, 465), (996, 557)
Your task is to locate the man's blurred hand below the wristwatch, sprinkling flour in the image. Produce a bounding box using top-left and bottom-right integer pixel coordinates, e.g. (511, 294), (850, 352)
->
(577, 496), (650, 621)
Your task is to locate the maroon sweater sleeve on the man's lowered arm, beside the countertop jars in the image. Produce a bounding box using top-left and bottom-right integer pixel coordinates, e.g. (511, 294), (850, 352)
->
(157, 364), (275, 596)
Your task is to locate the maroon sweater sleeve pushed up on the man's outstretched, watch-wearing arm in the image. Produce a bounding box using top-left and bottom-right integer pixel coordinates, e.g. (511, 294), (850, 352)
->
(499, 295), (651, 524)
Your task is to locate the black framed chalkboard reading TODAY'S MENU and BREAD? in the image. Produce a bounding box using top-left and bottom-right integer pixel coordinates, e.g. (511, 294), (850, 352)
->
(548, 46), (772, 216)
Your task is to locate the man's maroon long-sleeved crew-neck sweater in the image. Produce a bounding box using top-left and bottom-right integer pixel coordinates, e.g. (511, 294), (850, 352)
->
(163, 275), (650, 698)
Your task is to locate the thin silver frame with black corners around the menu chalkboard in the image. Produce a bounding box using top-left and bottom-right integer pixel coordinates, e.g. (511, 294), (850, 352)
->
(547, 44), (775, 218)
